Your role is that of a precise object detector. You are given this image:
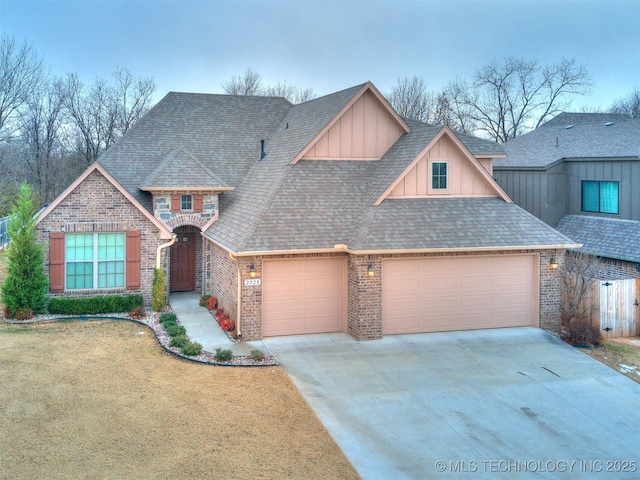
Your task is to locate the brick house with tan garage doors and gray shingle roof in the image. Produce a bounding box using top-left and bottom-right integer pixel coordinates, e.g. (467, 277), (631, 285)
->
(37, 83), (578, 340)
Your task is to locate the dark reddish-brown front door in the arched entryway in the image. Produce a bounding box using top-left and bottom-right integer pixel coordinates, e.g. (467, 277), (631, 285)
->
(169, 226), (202, 292)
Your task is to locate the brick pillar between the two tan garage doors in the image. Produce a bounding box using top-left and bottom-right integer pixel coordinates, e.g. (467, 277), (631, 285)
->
(347, 255), (382, 340)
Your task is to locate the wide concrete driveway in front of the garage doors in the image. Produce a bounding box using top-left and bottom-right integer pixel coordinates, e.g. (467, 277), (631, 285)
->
(264, 328), (640, 480)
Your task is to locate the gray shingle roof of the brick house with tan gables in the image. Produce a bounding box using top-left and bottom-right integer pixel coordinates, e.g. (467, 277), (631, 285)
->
(95, 84), (572, 252)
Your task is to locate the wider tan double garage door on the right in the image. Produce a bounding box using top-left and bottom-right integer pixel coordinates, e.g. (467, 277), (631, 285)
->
(382, 255), (538, 334)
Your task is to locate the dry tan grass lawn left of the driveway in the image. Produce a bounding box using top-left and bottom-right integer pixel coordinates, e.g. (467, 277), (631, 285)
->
(0, 321), (358, 480)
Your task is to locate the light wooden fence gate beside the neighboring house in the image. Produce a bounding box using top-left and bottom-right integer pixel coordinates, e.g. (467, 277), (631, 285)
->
(591, 278), (640, 338)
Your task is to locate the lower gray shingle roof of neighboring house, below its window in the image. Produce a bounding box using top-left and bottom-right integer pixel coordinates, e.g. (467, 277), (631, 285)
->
(556, 215), (640, 263)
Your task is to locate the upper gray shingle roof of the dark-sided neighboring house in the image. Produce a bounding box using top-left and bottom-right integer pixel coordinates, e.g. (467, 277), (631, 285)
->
(494, 113), (640, 169)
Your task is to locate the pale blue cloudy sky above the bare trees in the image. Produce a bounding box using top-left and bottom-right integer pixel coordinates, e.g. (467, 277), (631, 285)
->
(0, 0), (640, 110)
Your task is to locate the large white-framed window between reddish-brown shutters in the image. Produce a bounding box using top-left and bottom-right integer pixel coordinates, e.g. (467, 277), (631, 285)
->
(65, 233), (125, 290)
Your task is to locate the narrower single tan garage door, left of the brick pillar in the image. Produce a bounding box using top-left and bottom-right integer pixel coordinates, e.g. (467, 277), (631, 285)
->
(262, 258), (347, 337)
